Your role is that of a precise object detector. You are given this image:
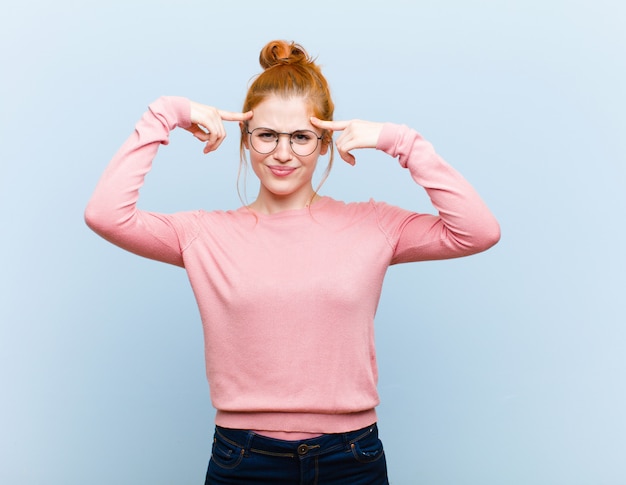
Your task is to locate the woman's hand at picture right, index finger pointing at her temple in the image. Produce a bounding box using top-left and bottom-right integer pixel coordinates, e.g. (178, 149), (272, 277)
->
(311, 116), (383, 165)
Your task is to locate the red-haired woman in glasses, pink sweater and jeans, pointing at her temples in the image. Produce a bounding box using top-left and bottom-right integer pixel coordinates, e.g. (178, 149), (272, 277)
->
(85, 41), (500, 485)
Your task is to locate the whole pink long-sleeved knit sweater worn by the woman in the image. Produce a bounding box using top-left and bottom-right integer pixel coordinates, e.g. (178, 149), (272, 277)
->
(85, 97), (500, 433)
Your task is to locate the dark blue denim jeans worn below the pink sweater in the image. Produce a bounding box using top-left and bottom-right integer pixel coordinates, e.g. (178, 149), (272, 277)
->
(204, 424), (389, 485)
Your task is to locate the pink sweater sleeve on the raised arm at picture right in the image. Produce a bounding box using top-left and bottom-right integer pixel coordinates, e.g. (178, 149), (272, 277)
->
(377, 123), (500, 264)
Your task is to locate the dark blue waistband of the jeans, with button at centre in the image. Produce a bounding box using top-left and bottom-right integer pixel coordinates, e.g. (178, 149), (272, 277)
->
(215, 423), (378, 458)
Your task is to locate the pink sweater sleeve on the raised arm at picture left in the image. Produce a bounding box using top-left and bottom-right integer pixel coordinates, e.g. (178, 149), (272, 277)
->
(85, 96), (191, 266)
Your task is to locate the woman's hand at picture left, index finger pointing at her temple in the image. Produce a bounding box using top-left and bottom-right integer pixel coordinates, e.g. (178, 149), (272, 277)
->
(185, 101), (252, 153)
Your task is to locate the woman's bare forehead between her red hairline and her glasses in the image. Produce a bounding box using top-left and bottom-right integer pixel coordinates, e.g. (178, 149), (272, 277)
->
(250, 95), (313, 131)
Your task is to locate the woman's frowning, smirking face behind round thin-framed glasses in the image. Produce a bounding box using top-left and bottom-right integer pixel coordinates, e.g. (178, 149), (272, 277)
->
(244, 95), (328, 207)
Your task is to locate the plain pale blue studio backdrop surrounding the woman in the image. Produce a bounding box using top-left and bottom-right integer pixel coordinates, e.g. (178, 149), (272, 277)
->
(0, 0), (626, 485)
